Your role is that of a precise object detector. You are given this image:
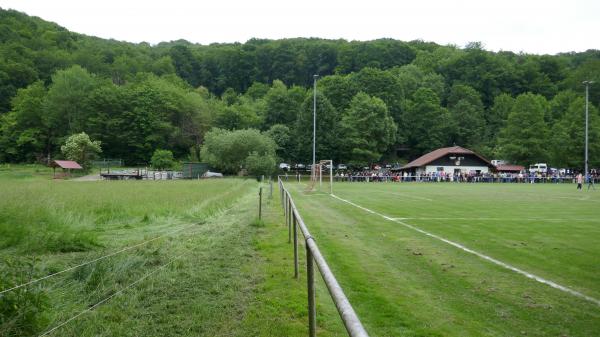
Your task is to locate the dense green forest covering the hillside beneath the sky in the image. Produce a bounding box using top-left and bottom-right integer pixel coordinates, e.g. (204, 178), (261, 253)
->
(0, 9), (600, 168)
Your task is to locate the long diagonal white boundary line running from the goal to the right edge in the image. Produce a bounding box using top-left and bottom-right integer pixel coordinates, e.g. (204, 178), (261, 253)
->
(331, 194), (600, 306)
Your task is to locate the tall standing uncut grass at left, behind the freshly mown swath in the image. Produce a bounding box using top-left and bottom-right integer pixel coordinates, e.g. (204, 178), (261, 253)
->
(0, 172), (250, 253)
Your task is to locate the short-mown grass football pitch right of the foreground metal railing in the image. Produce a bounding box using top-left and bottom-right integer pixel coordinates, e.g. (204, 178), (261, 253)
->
(286, 183), (600, 336)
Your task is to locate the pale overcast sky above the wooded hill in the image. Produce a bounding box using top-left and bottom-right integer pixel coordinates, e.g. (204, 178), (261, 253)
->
(0, 0), (600, 54)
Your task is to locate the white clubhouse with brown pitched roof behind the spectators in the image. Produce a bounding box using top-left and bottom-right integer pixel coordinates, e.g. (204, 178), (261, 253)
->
(400, 146), (495, 175)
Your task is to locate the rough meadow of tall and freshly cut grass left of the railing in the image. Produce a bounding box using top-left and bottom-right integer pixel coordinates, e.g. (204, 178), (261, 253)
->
(0, 166), (292, 336)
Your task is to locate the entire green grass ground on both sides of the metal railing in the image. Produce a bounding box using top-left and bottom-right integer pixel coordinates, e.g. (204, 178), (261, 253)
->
(0, 166), (600, 337)
